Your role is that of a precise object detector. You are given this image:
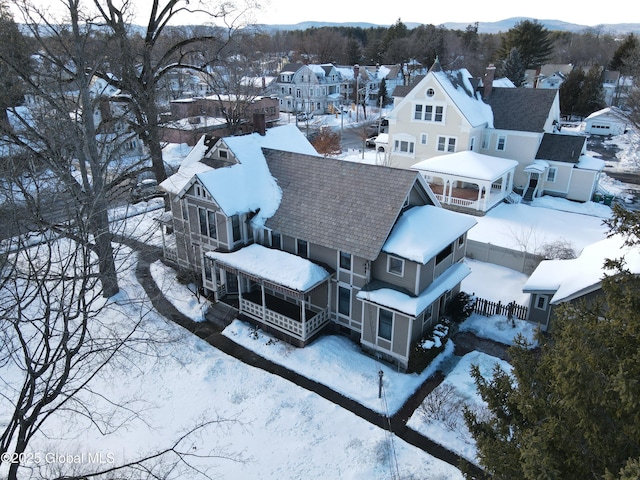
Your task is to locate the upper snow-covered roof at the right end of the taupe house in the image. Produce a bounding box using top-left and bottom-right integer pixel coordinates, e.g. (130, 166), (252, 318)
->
(382, 205), (477, 264)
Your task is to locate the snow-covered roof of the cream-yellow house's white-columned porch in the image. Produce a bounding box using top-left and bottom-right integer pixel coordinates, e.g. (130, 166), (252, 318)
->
(411, 150), (518, 181)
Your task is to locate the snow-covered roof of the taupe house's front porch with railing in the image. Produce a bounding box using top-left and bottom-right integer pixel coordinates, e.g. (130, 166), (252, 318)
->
(206, 244), (330, 292)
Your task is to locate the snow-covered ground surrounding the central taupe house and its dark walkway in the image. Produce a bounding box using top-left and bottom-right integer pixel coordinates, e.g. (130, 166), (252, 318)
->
(0, 118), (636, 480)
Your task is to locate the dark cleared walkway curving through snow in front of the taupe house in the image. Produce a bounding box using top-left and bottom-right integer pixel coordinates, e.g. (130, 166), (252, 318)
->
(127, 239), (492, 478)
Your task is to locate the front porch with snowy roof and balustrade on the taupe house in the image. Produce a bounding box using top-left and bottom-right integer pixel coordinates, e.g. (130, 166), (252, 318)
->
(207, 245), (331, 346)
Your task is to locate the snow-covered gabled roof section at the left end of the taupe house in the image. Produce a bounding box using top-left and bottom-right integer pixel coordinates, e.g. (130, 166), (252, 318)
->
(160, 124), (318, 224)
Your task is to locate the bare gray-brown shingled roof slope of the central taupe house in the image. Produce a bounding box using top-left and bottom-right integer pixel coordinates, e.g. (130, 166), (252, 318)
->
(263, 149), (419, 260)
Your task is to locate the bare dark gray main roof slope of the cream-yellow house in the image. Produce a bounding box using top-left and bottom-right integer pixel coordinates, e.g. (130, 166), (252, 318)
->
(484, 88), (558, 133)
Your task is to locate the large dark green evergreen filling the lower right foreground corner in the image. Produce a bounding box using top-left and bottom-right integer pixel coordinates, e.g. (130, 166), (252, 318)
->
(465, 207), (640, 479)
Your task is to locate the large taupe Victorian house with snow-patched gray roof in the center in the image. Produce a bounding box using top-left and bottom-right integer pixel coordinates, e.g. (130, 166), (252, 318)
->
(161, 125), (475, 368)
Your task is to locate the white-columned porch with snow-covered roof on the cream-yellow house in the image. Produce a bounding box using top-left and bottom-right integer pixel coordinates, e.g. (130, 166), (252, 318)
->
(412, 151), (518, 212)
